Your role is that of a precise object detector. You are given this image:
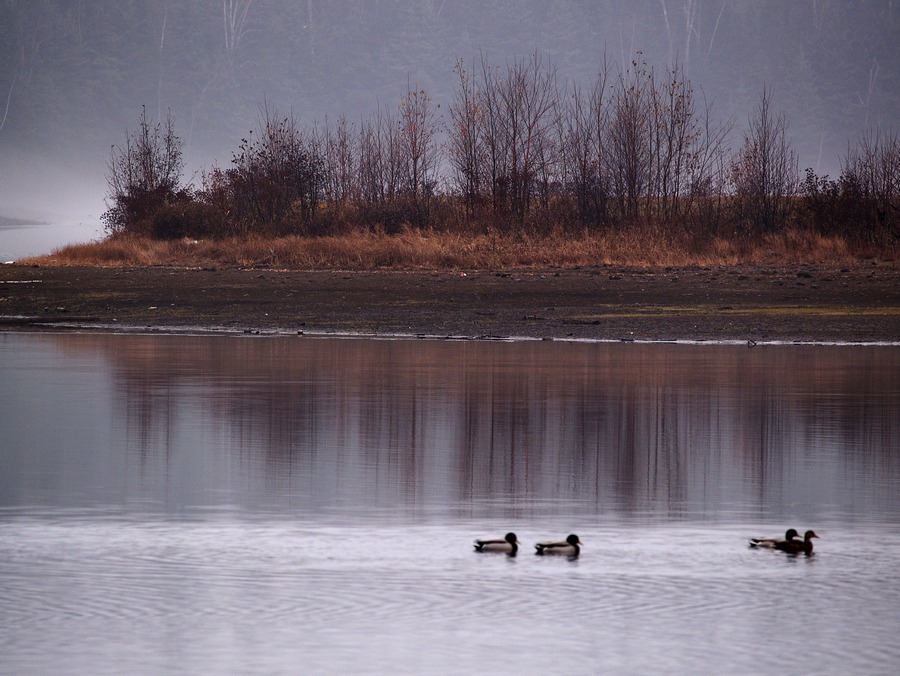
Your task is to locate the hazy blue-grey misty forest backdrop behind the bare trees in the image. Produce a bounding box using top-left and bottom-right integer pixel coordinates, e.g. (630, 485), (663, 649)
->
(0, 0), (900, 235)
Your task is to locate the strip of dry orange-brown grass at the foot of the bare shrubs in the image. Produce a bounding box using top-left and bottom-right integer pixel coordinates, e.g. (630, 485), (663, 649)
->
(27, 227), (900, 270)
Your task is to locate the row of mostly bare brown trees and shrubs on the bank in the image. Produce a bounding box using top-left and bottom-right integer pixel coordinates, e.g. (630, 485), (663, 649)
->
(95, 54), (900, 251)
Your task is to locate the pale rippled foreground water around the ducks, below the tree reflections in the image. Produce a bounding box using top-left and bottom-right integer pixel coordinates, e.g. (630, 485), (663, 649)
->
(0, 520), (900, 673)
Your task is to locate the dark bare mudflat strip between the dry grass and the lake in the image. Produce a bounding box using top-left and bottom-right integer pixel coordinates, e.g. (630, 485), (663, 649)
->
(0, 261), (900, 344)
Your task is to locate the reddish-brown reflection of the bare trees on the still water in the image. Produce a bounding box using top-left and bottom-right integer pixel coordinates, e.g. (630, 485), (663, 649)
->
(15, 335), (900, 518)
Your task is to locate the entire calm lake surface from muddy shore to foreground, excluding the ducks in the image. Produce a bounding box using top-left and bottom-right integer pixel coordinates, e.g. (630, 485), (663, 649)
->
(0, 333), (900, 674)
